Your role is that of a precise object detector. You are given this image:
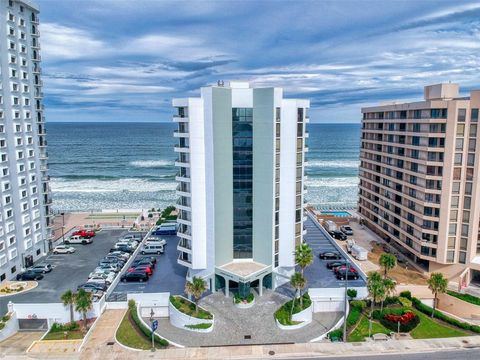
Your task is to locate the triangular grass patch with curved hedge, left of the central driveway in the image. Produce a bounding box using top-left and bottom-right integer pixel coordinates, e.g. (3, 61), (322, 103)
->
(115, 300), (168, 350)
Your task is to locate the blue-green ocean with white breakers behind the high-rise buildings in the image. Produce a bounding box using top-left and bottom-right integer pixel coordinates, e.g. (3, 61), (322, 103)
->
(47, 123), (360, 211)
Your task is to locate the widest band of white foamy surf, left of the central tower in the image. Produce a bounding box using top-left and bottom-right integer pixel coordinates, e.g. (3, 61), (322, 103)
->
(50, 178), (176, 193)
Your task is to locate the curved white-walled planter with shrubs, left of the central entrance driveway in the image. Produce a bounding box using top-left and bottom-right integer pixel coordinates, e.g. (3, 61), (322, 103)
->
(168, 295), (214, 332)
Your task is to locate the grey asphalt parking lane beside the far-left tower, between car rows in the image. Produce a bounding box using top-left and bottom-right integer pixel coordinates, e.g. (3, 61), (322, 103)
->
(0, 230), (127, 314)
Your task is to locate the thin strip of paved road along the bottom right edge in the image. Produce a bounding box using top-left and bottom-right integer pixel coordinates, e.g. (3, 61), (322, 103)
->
(286, 349), (480, 360)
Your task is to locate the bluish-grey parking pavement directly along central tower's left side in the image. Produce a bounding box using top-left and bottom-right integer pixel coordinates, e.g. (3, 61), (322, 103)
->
(107, 236), (187, 301)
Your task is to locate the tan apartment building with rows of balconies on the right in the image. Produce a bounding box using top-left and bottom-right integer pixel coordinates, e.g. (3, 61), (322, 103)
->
(358, 84), (480, 284)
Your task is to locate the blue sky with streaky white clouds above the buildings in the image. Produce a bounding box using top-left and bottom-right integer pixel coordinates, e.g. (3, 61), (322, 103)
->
(36, 0), (480, 123)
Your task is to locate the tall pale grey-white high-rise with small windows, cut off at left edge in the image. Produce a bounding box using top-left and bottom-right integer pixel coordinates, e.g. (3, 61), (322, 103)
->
(0, 0), (51, 281)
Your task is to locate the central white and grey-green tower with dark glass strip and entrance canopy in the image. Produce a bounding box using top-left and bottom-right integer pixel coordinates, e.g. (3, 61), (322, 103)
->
(173, 81), (309, 295)
